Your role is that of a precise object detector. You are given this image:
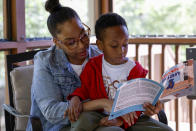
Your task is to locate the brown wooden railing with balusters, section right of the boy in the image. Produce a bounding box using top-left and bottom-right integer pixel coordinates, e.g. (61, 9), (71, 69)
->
(129, 37), (196, 131)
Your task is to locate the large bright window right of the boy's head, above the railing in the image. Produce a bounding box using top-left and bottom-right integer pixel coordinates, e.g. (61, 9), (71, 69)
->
(114, 0), (196, 35)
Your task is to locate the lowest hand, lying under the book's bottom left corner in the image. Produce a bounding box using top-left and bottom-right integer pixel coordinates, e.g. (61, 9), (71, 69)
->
(99, 117), (123, 127)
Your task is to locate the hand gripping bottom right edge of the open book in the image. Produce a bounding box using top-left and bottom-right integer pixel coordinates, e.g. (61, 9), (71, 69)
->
(143, 101), (163, 116)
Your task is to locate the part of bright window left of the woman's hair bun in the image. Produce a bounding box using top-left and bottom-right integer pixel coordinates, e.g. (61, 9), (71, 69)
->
(25, 0), (50, 38)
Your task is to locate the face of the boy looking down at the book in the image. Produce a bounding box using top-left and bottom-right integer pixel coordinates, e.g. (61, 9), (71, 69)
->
(97, 26), (129, 65)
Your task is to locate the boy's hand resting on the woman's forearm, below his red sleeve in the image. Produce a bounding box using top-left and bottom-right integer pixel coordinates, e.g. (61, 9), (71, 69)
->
(64, 96), (82, 122)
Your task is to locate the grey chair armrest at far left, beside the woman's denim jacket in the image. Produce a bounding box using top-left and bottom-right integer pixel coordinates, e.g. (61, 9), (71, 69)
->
(3, 104), (30, 117)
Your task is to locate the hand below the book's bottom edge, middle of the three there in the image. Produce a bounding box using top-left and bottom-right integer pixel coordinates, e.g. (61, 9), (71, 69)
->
(121, 112), (138, 126)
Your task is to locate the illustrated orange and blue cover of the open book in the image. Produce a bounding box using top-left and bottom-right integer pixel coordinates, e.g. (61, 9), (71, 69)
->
(160, 59), (194, 102)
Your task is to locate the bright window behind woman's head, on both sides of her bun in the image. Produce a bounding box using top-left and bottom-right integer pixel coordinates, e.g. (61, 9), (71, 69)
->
(25, 0), (94, 38)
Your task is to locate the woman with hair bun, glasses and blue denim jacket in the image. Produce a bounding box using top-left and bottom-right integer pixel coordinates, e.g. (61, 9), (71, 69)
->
(27, 0), (104, 131)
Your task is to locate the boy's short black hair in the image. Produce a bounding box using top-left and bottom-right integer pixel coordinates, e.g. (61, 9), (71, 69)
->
(95, 13), (128, 40)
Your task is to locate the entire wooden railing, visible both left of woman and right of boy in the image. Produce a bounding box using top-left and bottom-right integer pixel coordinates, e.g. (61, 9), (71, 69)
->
(0, 37), (196, 131)
